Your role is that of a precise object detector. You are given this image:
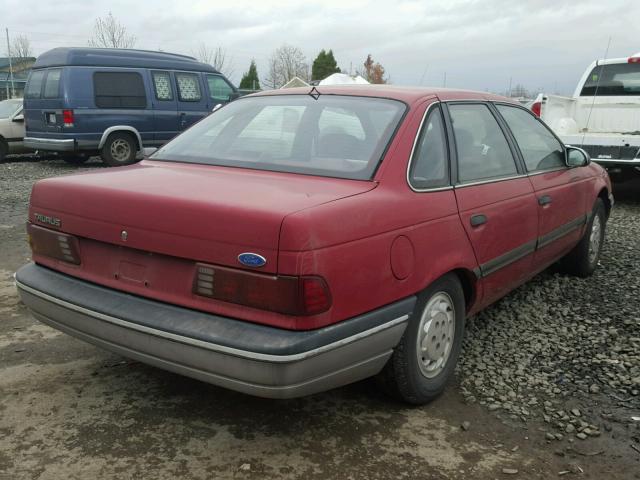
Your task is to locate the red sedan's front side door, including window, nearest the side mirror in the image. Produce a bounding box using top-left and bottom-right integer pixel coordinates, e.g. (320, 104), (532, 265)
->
(496, 104), (590, 268)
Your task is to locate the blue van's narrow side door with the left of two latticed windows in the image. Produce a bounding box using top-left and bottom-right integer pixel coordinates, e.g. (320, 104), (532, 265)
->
(151, 70), (180, 144)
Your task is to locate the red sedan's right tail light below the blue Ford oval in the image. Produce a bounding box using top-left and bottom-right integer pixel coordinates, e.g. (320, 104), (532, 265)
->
(193, 264), (331, 315)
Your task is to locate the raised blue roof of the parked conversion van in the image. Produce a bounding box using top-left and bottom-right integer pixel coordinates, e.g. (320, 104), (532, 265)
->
(33, 47), (218, 73)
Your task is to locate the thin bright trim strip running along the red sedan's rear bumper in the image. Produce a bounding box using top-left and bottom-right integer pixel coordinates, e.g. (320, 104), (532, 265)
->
(16, 279), (409, 363)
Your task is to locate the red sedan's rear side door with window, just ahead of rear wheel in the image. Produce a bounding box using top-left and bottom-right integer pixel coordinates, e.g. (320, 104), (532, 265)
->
(446, 102), (538, 305)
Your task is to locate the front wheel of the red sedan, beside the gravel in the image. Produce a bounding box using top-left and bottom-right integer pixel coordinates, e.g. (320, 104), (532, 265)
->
(560, 198), (607, 277)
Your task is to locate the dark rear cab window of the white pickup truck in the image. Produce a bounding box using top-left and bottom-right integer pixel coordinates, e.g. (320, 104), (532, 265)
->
(580, 63), (640, 97)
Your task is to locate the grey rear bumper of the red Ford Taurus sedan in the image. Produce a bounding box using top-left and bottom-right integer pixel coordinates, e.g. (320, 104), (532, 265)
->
(16, 264), (415, 398)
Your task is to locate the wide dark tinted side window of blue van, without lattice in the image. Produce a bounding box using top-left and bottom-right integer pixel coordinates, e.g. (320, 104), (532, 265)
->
(93, 72), (147, 108)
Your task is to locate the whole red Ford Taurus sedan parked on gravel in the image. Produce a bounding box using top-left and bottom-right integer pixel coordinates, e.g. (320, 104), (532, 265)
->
(16, 86), (613, 403)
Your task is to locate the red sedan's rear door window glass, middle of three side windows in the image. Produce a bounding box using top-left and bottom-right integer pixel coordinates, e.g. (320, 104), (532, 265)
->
(449, 104), (518, 182)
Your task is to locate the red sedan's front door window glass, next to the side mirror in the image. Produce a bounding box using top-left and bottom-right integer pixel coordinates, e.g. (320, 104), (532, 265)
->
(497, 105), (565, 172)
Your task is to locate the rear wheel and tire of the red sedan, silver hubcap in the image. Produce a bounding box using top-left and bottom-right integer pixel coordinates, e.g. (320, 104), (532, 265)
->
(377, 274), (465, 405)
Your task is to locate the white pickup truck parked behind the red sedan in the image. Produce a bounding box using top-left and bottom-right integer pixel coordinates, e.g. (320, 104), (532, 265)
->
(531, 52), (640, 180)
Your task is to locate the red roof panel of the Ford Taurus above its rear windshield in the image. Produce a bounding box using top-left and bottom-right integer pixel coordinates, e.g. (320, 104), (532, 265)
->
(252, 85), (517, 103)
